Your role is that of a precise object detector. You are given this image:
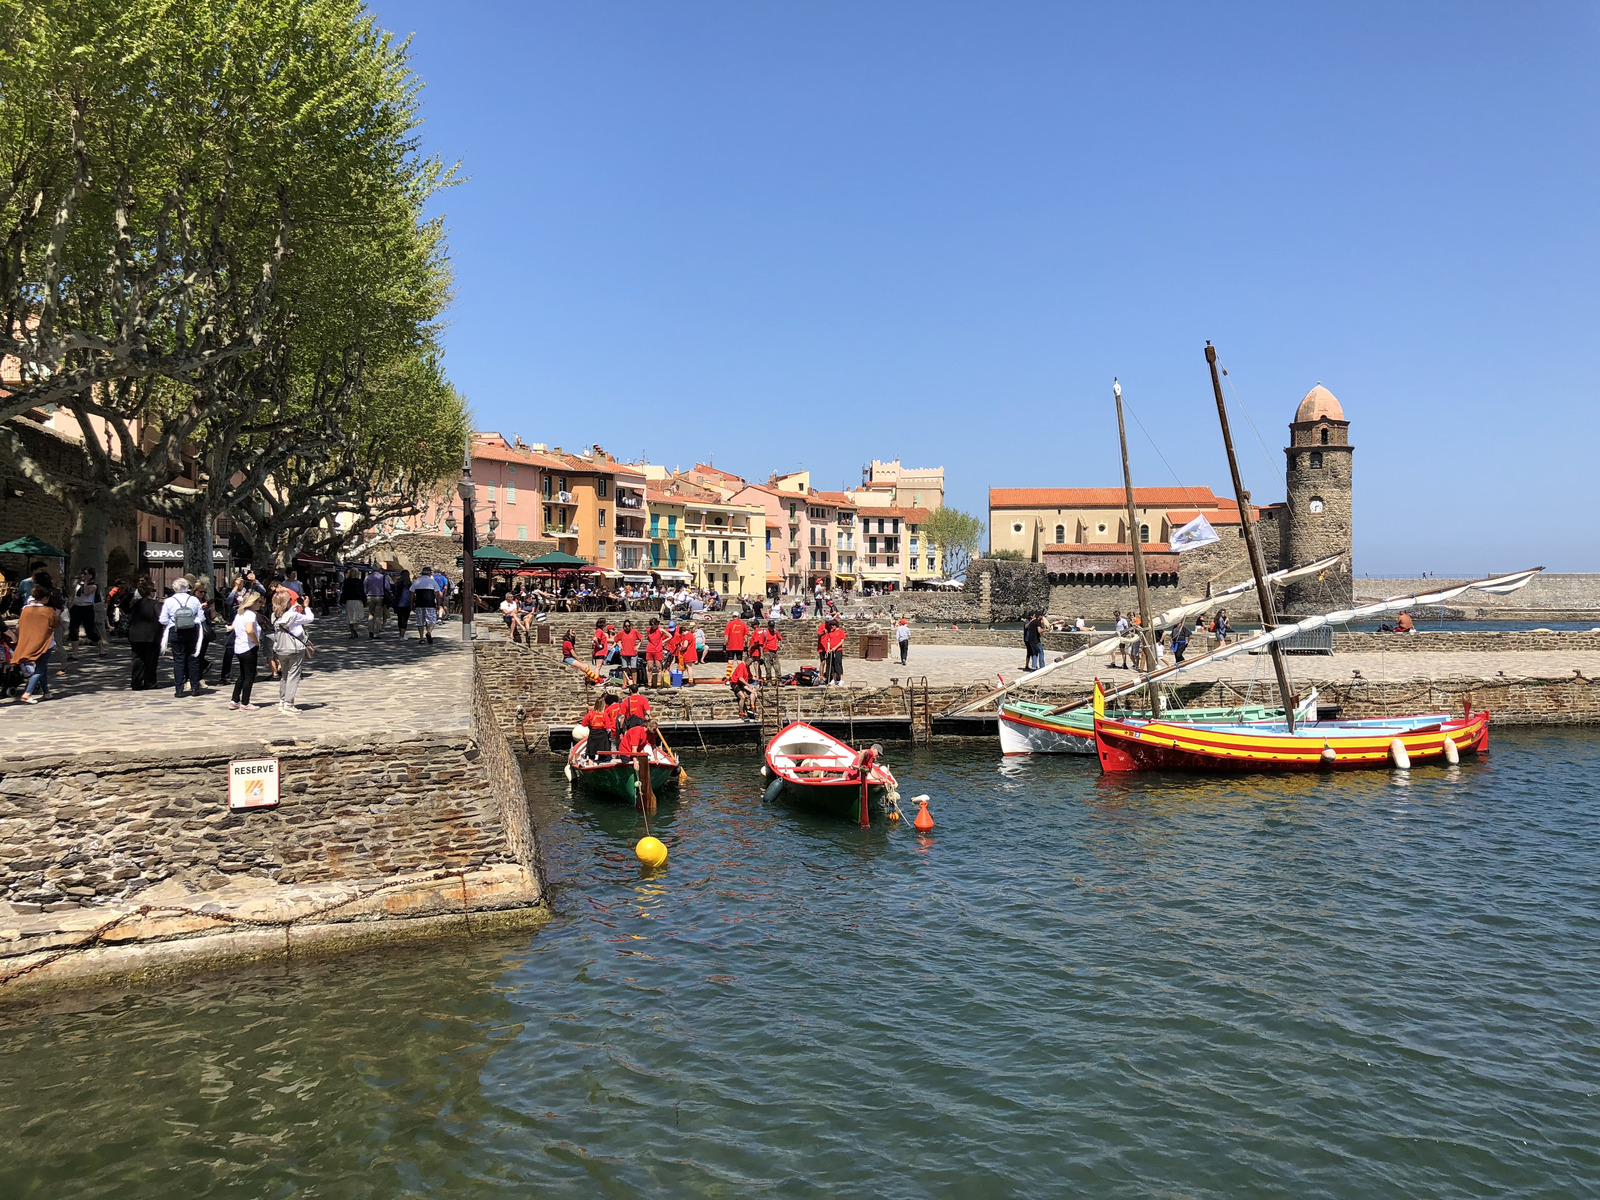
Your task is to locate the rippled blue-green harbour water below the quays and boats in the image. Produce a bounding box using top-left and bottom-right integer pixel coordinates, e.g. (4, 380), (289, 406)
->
(0, 731), (1600, 1200)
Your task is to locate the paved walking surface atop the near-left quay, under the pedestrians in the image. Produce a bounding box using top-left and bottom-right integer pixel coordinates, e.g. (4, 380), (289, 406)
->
(0, 621), (472, 757)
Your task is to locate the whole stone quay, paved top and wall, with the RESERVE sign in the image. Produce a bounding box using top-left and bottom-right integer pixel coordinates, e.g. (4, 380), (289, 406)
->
(0, 630), (547, 998)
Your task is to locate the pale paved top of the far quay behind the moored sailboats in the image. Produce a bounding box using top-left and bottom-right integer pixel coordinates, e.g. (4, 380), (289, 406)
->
(825, 642), (1600, 686)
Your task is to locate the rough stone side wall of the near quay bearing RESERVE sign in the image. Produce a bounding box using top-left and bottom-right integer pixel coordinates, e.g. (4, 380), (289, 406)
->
(0, 654), (546, 998)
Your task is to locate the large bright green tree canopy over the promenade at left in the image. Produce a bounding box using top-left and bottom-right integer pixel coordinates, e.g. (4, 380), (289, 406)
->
(0, 0), (466, 570)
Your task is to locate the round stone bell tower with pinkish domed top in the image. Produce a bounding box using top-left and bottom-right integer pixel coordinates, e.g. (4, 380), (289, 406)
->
(1282, 384), (1355, 614)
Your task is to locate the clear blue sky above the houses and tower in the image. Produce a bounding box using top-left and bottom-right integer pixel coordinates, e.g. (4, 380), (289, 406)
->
(373, 0), (1600, 573)
